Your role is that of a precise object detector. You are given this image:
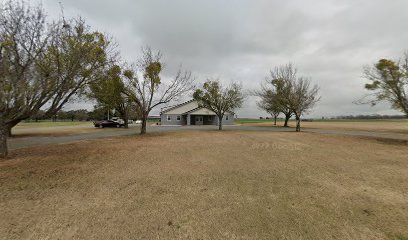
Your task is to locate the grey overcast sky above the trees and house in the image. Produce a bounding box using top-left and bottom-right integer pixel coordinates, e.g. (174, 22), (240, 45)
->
(36, 0), (408, 117)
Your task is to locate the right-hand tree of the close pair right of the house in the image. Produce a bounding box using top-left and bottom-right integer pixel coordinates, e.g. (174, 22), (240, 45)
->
(288, 77), (320, 132)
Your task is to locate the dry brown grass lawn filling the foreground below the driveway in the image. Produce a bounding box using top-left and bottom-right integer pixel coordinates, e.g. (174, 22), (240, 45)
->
(0, 131), (408, 240)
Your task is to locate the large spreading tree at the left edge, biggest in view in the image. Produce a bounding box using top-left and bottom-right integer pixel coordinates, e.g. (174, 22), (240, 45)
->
(0, 0), (111, 157)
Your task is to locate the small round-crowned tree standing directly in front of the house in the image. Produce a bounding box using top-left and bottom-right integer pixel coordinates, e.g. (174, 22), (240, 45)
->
(193, 80), (245, 130)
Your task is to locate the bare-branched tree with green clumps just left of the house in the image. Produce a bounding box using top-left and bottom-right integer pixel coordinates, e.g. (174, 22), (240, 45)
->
(124, 47), (194, 134)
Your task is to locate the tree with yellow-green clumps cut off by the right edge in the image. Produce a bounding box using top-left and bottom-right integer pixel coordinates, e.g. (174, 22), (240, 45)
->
(359, 52), (408, 117)
